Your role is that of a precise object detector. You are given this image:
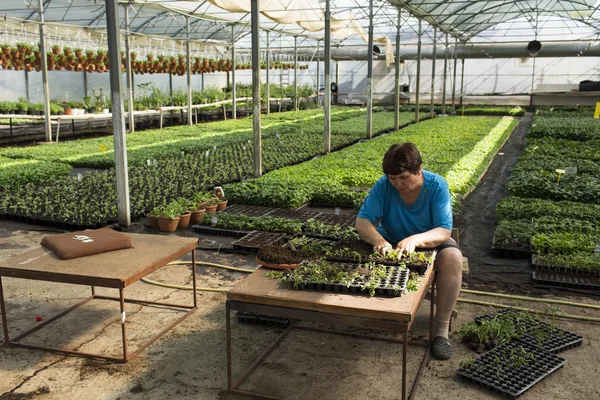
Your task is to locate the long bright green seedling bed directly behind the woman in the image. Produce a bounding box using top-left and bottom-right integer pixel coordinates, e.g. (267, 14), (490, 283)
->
(226, 117), (517, 210)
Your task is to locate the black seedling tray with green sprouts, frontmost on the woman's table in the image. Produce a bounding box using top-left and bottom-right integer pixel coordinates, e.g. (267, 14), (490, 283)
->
(266, 260), (409, 297)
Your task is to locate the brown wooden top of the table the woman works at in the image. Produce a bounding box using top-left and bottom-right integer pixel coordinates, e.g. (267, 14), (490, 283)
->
(227, 267), (433, 323)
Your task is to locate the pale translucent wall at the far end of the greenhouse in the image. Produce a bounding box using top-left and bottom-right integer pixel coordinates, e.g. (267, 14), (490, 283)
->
(0, 57), (600, 104)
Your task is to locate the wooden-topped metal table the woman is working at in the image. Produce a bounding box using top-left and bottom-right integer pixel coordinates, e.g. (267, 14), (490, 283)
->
(226, 266), (435, 400)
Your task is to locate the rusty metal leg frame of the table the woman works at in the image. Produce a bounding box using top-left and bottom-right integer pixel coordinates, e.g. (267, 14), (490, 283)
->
(225, 272), (437, 400)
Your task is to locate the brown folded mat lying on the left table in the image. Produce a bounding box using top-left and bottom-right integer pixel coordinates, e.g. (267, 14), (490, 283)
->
(42, 228), (133, 260)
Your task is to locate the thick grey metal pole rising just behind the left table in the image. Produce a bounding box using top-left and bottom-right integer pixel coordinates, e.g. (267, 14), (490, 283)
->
(106, 0), (131, 226)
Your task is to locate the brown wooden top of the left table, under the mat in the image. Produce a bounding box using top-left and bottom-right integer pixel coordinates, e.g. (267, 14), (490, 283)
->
(0, 233), (198, 288)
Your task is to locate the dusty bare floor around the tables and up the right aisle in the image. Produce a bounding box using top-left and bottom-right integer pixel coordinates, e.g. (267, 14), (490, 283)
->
(0, 117), (600, 400)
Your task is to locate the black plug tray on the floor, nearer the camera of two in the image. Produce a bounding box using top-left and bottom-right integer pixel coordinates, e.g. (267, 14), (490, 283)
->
(457, 341), (567, 399)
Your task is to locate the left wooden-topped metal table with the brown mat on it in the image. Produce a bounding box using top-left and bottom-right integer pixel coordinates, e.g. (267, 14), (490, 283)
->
(0, 233), (198, 363)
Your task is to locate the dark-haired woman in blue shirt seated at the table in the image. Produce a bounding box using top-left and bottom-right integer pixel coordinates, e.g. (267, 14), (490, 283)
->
(356, 143), (463, 360)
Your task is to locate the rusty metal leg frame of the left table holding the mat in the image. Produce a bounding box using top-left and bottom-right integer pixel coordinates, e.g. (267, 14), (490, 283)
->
(0, 250), (198, 363)
